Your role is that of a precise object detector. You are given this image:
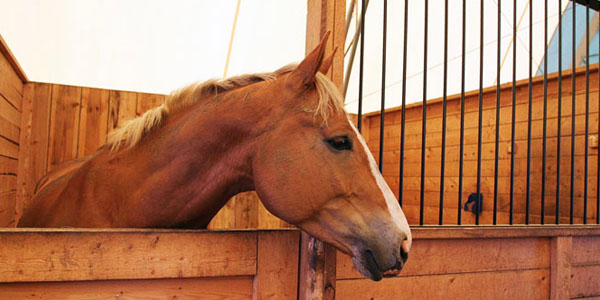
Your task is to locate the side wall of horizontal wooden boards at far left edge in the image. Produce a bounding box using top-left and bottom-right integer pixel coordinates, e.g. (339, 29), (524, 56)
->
(0, 36), (27, 227)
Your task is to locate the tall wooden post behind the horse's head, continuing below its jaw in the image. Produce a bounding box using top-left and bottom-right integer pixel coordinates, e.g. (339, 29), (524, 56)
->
(298, 0), (346, 300)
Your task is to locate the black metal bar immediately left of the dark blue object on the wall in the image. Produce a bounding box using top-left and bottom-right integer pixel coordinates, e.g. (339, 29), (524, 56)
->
(457, 0), (467, 225)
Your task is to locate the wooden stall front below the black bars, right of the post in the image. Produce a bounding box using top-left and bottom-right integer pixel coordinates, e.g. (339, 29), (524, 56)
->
(336, 227), (600, 300)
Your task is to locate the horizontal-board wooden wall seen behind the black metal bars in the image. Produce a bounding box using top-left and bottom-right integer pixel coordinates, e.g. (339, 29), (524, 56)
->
(363, 65), (598, 224)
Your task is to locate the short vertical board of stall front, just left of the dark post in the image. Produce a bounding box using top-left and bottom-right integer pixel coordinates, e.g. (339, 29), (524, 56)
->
(254, 231), (300, 300)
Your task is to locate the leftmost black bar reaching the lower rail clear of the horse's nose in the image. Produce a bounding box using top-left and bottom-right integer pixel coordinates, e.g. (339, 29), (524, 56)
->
(419, 0), (429, 225)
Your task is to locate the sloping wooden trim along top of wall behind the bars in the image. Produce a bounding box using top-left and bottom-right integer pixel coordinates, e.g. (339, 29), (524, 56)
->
(363, 63), (600, 118)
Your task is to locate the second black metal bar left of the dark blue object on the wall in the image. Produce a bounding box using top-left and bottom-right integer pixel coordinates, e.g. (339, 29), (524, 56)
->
(438, 0), (448, 225)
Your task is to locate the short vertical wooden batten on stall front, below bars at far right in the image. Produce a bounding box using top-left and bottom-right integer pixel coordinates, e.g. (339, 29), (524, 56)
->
(550, 236), (573, 300)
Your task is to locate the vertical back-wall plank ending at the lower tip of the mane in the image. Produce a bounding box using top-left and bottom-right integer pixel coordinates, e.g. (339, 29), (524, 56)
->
(77, 88), (109, 157)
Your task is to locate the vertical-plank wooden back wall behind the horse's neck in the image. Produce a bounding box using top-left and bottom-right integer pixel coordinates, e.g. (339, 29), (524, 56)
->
(11, 82), (289, 229)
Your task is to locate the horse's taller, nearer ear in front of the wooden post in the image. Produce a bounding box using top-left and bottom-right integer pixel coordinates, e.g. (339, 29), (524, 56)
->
(288, 31), (330, 89)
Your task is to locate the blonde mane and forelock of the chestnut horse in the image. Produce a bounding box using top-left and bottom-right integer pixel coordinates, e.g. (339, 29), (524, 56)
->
(106, 65), (345, 151)
